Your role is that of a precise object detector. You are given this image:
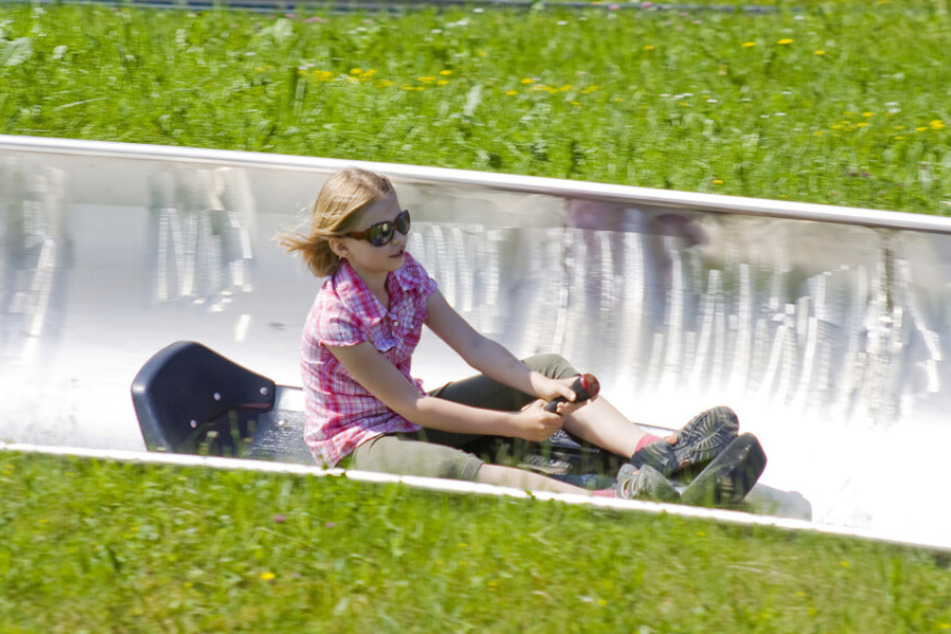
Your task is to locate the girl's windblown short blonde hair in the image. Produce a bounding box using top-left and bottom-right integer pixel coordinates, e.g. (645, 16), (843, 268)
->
(278, 167), (393, 277)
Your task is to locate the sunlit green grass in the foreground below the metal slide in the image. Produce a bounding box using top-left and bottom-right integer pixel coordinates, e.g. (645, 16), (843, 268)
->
(0, 452), (951, 633)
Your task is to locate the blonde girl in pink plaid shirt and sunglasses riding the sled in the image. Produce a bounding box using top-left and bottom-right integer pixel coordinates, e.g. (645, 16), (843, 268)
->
(282, 168), (738, 499)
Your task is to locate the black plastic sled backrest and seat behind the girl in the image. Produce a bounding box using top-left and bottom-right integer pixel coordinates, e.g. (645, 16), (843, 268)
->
(132, 341), (314, 464)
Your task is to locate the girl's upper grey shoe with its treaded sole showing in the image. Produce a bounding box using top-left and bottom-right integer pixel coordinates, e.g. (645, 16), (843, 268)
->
(631, 407), (740, 476)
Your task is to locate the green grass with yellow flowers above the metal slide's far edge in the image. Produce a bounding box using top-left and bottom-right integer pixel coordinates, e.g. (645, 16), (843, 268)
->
(0, 0), (951, 214)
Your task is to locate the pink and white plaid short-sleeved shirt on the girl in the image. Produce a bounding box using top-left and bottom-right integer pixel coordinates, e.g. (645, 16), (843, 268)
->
(301, 253), (436, 467)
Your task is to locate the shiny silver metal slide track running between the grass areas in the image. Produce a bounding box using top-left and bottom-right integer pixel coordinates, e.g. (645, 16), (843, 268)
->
(0, 136), (951, 548)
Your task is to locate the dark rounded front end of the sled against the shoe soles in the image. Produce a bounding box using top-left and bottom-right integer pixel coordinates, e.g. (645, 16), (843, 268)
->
(680, 434), (766, 506)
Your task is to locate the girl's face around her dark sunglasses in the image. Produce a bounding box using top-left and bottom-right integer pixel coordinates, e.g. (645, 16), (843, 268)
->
(337, 192), (407, 281)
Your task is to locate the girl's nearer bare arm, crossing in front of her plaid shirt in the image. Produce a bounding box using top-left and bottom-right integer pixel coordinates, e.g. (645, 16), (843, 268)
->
(328, 341), (573, 442)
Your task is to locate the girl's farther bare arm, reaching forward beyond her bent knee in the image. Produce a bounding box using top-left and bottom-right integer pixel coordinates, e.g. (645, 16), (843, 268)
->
(426, 290), (575, 401)
